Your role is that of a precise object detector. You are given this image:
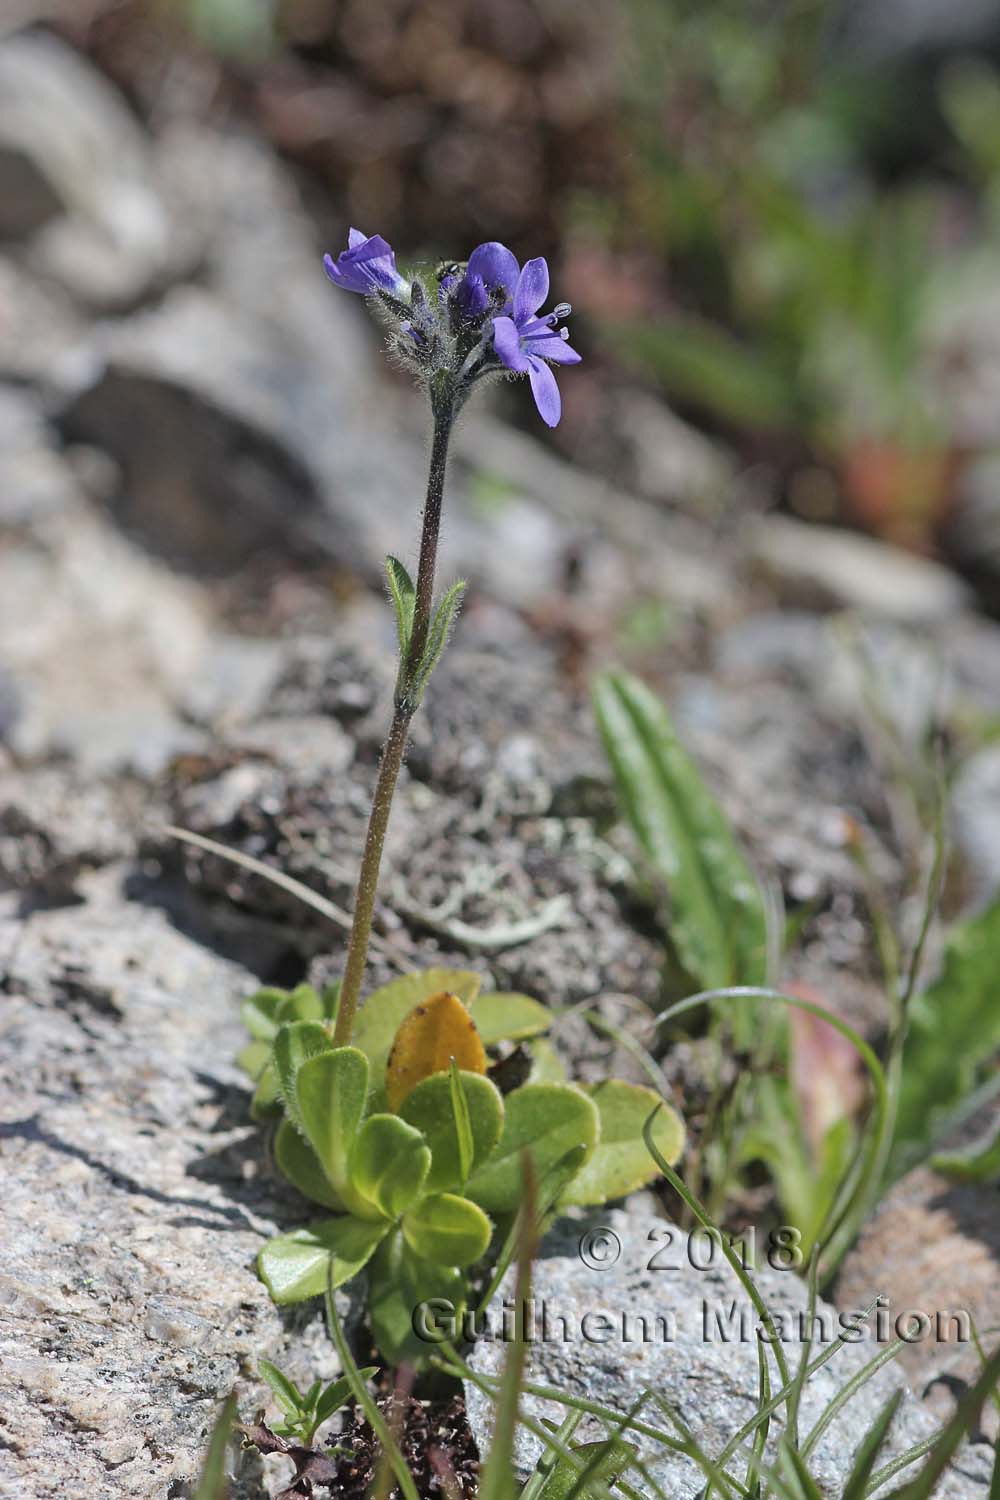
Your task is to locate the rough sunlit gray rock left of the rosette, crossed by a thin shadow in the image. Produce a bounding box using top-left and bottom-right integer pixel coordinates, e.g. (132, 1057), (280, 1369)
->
(0, 870), (344, 1500)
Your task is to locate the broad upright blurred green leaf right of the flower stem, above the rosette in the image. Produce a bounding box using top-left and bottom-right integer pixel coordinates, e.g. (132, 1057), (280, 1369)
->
(594, 672), (768, 989)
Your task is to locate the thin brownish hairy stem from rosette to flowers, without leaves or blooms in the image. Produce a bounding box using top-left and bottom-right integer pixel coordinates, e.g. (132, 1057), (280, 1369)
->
(333, 405), (453, 1047)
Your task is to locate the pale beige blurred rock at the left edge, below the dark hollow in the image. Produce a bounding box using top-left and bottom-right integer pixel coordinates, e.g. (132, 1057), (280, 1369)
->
(0, 441), (210, 776)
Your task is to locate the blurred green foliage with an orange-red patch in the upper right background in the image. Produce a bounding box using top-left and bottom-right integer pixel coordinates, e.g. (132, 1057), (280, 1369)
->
(574, 0), (1000, 546)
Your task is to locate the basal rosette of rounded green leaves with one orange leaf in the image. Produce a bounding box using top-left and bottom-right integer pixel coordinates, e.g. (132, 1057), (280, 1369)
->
(244, 969), (684, 1359)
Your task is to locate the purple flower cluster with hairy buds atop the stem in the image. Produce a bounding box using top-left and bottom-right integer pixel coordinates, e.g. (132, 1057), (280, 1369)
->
(324, 230), (580, 428)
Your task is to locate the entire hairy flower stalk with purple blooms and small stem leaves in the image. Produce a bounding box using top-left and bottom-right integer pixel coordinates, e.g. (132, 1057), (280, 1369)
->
(324, 230), (580, 1046)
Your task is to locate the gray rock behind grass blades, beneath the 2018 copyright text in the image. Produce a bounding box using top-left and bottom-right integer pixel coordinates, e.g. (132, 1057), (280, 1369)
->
(465, 1208), (991, 1500)
